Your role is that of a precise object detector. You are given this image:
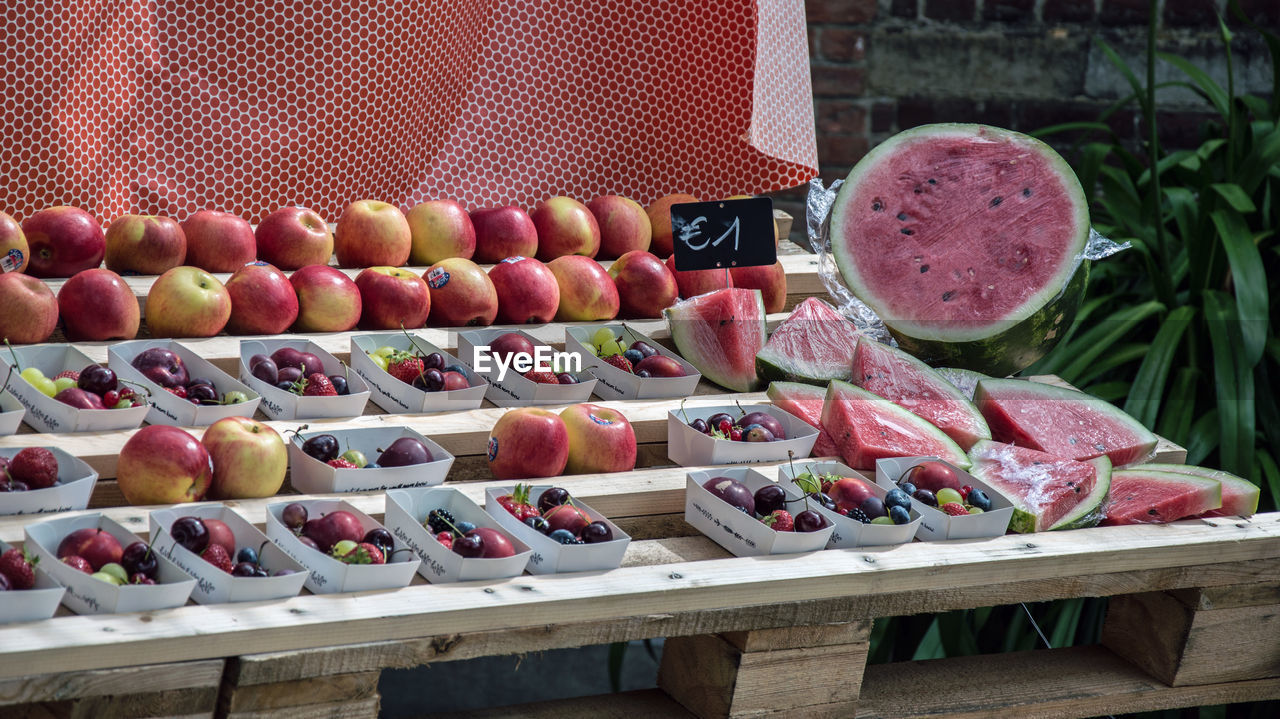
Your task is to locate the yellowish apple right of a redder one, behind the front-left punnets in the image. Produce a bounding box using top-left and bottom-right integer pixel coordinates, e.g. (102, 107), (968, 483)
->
(200, 417), (289, 498)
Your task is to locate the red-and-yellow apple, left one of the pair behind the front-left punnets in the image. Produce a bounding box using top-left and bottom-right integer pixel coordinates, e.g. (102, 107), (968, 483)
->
(115, 425), (214, 505)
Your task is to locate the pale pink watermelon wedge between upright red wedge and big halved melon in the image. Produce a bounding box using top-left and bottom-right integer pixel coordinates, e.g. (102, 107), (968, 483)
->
(755, 297), (859, 385)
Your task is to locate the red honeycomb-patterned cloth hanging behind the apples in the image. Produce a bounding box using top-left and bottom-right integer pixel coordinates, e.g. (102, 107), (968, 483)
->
(0, 0), (817, 221)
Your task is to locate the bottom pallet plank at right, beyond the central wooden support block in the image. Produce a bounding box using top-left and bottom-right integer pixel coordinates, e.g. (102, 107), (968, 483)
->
(858, 646), (1280, 719)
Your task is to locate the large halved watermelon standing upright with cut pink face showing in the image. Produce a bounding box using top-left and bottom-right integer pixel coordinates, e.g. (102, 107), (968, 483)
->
(831, 124), (1089, 376)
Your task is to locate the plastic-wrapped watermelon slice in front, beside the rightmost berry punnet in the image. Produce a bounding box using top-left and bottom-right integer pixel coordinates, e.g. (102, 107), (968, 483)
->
(969, 440), (1111, 532)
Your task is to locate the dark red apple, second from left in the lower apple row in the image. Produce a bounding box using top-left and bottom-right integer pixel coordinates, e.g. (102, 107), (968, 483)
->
(58, 269), (140, 342)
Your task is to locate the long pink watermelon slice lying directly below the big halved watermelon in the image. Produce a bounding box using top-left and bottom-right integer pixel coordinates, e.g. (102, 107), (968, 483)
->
(854, 336), (991, 450)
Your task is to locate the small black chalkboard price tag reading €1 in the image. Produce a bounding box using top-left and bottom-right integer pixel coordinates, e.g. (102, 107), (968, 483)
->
(671, 197), (778, 271)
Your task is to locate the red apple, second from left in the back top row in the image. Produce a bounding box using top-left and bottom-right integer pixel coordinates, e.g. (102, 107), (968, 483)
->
(22, 207), (106, 278)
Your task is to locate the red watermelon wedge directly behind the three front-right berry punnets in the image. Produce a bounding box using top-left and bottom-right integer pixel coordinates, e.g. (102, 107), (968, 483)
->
(820, 380), (969, 470)
